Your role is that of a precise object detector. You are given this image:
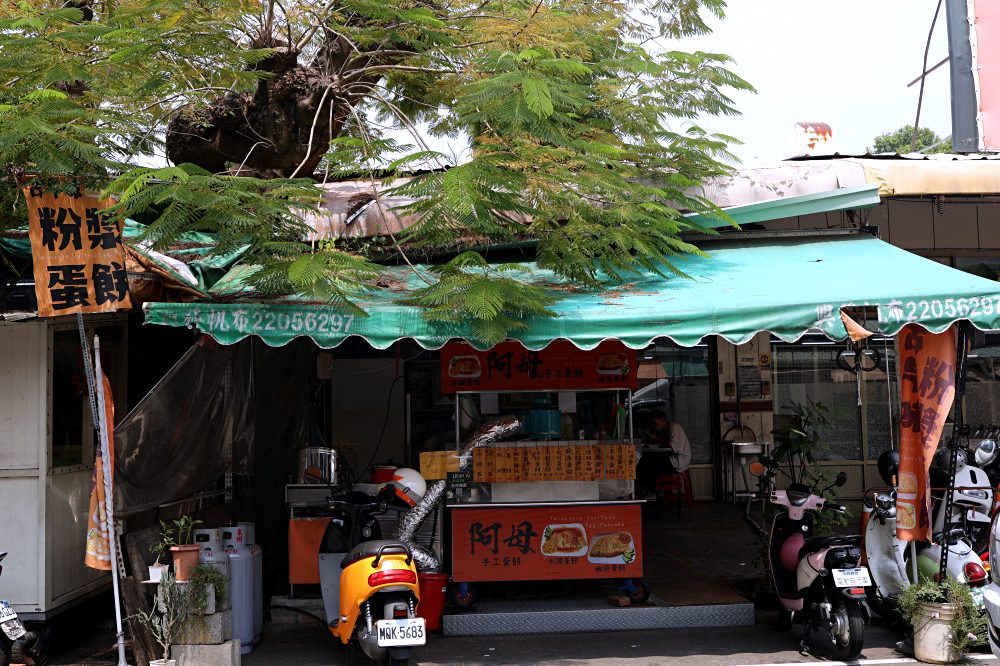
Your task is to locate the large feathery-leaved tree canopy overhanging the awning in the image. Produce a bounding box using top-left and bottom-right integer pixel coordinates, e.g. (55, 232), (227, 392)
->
(0, 0), (751, 342)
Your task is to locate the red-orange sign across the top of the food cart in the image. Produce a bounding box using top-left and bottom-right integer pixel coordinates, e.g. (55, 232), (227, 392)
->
(441, 340), (638, 393)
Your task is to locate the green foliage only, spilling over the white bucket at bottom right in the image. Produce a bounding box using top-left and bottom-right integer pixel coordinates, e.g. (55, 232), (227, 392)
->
(899, 577), (987, 658)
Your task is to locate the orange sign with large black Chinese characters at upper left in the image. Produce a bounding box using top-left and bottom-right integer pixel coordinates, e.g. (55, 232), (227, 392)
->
(24, 186), (132, 317)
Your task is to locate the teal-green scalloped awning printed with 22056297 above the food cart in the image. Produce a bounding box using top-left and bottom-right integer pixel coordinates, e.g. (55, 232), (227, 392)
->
(146, 232), (1000, 349)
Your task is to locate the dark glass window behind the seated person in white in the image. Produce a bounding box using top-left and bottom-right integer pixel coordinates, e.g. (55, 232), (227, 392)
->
(633, 343), (712, 464)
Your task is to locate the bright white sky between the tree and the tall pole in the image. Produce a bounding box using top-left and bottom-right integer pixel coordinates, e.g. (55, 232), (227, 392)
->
(666, 0), (951, 165)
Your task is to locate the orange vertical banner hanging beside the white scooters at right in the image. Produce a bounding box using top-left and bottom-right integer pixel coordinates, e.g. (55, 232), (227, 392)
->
(896, 324), (958, 541)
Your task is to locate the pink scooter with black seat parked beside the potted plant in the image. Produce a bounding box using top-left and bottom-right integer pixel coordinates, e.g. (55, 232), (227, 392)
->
(756, 475), (871, 660)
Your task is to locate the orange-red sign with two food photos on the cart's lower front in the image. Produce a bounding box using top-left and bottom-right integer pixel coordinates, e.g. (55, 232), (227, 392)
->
(451, 503), (642, 582)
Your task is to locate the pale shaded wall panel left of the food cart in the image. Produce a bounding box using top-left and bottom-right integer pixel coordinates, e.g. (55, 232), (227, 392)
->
(330, 358), (404, 473)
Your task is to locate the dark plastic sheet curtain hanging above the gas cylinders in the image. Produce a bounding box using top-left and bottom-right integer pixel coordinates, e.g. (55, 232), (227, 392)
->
(115, 336), (312, 516)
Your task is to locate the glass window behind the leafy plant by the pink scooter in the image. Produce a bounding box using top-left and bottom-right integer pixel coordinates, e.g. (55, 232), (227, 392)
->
(771, 341), (861, 460)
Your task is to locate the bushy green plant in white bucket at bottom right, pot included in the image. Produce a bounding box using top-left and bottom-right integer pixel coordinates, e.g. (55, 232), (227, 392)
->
(899, 578), (987, 664)
